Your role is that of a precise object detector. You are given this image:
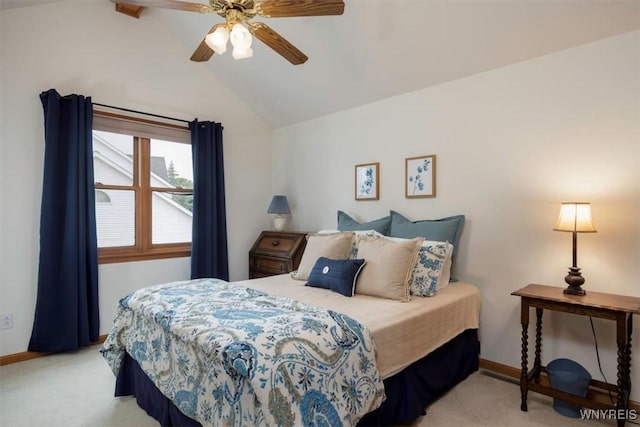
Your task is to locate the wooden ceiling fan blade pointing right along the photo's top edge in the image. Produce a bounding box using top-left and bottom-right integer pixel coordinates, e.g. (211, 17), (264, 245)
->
(256, 0), (344, 18)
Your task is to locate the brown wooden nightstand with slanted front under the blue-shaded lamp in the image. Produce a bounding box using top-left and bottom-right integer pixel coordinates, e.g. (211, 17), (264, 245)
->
(249, 231), (307, 279)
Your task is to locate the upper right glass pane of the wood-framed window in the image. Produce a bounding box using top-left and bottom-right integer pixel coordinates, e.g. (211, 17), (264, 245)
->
(151, 139), (193, 188)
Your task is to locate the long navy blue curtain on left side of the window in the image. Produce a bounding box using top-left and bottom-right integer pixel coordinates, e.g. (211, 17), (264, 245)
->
(29, 89), (100, 351)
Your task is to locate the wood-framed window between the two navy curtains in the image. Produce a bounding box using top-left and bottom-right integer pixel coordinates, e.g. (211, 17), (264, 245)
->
(93, 112), (193, 263)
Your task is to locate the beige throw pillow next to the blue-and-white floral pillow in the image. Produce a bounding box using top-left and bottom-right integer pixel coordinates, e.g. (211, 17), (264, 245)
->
(356, 236), (424, 301)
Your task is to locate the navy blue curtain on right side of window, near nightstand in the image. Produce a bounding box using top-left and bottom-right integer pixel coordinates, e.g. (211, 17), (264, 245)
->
(189, 119), (229, 280)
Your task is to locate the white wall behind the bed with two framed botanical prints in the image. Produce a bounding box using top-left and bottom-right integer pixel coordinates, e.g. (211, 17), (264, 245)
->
(273, 32), (640, 401)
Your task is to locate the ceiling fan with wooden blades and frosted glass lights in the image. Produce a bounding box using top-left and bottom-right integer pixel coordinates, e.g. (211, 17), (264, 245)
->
(111, 0), (344, 65)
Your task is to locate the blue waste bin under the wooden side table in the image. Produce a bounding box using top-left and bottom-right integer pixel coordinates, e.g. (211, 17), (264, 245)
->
(547, 359), (591, 418)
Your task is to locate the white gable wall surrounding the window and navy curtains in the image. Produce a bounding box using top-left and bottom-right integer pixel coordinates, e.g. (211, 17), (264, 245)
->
(0, 1), (272, 355)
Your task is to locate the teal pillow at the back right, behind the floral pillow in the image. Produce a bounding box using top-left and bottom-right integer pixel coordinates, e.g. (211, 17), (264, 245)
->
(389, 211), (465, 281)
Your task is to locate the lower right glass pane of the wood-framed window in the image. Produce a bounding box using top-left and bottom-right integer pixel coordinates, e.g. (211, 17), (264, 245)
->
(151, 191), (193, 244)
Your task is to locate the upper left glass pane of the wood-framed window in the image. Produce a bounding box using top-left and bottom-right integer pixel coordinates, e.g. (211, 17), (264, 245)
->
(93, 130), (133, 185)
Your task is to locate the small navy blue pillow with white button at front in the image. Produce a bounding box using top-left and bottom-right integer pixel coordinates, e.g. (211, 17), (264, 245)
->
(305, 257), (365, 297)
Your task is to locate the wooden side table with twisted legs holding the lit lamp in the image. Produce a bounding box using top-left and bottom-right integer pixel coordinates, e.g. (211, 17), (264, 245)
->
(511, 285), (640, 426)
